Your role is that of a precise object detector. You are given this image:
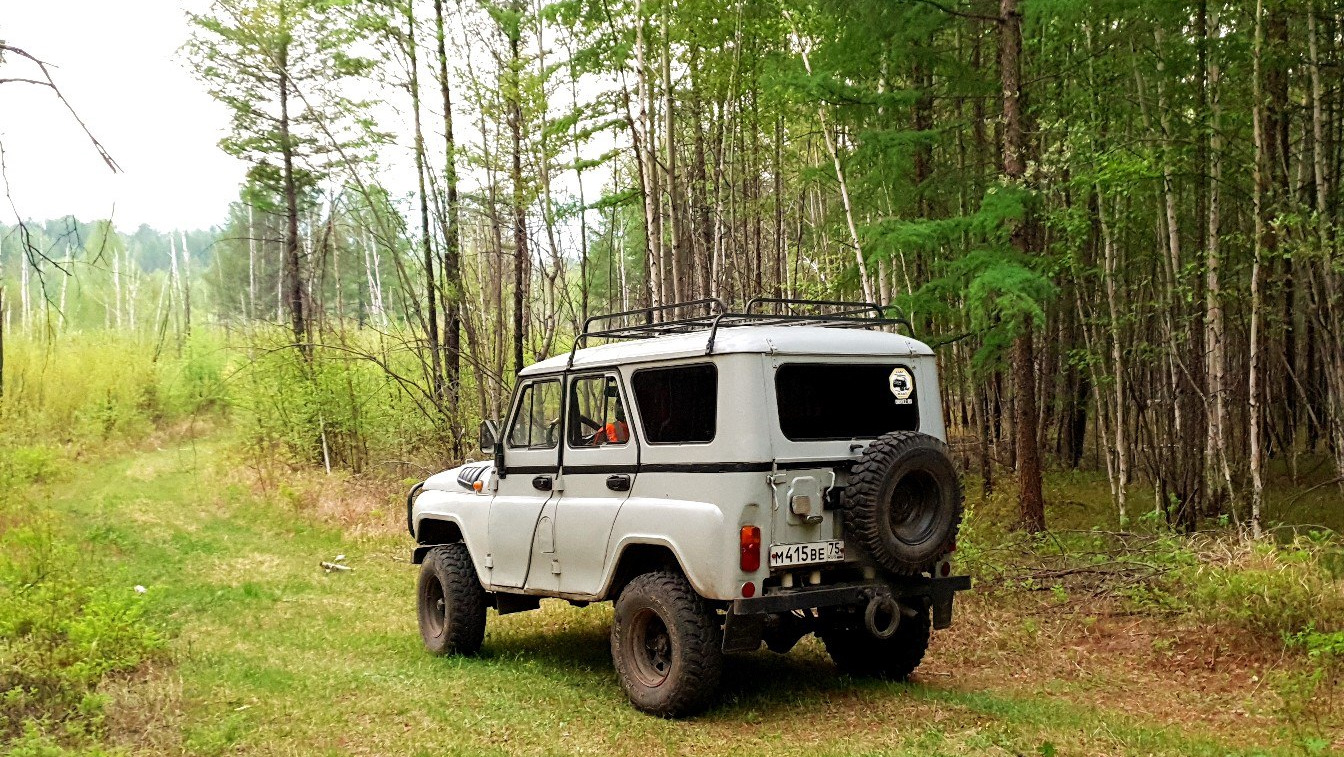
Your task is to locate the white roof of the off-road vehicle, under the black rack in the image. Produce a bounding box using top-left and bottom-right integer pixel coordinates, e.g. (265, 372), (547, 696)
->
(521, 325), (933, 375)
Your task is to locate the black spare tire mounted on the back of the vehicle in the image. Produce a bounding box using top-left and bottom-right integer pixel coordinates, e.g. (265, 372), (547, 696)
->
(844, 432), (962, 574)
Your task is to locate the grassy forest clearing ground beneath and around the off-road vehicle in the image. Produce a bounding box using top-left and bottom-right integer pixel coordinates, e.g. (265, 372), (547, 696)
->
(13, 437), (1344, 757)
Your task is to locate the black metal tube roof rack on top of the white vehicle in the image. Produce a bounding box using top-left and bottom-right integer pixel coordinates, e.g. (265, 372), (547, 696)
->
(566, 297), (914, 370)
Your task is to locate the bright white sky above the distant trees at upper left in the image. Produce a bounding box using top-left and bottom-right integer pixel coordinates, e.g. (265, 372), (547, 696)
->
(0, 0), (245, 231)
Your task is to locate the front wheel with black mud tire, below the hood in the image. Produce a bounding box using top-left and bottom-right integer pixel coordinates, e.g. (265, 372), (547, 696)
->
(415, 542), (485, 655)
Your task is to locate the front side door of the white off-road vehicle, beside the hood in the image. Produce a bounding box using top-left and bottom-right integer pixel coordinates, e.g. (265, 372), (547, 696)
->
(487, 379), (562, 588)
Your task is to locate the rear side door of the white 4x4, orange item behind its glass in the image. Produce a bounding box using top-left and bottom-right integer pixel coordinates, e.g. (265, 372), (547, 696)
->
(548, 372), (640, 594)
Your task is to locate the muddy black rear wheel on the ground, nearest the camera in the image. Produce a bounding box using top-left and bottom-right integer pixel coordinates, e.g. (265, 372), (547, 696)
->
(612, 571), (723, 718)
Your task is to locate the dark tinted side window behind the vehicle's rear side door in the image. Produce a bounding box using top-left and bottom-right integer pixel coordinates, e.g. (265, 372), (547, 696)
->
(632, 364), (719, 444)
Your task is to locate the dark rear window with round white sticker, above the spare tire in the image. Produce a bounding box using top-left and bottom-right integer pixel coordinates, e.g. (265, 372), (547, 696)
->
(774, 363), (919, 441)
